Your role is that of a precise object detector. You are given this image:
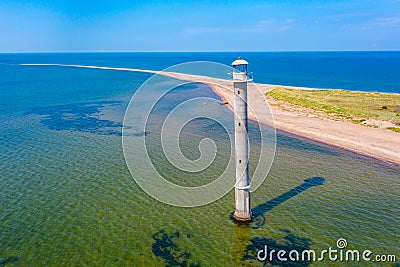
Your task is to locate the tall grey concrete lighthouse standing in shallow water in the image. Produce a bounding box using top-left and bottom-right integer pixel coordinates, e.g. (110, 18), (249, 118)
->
(232, 57), (252, 222)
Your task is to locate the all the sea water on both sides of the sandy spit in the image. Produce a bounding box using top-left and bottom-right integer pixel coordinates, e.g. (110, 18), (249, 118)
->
(0, 51), (400, 266)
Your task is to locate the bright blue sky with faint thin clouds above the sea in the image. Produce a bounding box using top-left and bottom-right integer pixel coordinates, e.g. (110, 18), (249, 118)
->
(0, 0), (400, 52)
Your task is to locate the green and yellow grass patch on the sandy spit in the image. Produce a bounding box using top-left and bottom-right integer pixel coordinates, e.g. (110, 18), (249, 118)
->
(266, 87), (400, 131)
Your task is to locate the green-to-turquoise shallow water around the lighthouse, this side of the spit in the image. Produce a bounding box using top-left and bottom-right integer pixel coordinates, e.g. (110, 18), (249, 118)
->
(0, 54), (400, 266)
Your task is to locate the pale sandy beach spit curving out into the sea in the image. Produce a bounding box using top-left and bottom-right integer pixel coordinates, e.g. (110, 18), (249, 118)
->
(21, 64), (400, 166)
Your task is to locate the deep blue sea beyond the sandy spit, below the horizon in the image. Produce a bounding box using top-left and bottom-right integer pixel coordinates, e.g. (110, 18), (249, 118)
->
(0, 51), (400, 93)
